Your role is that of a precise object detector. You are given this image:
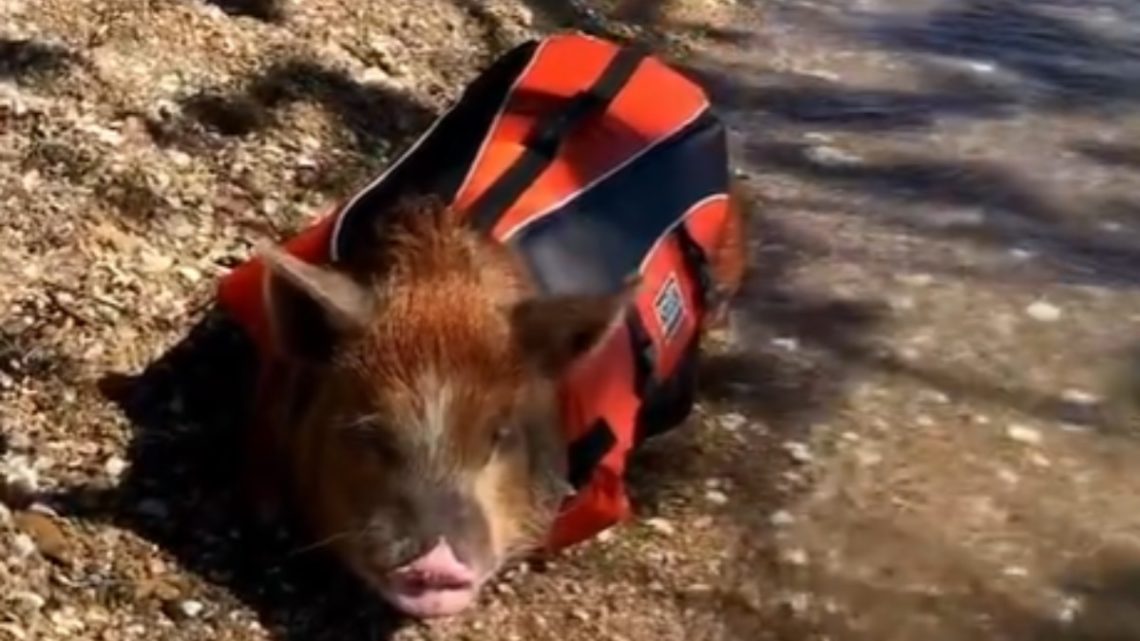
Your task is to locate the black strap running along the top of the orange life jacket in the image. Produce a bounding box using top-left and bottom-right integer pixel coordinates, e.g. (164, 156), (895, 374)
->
(470, 47), (646, 230)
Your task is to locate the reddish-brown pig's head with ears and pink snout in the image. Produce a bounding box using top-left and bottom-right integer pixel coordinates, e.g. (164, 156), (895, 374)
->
(262, 200), (632, 617)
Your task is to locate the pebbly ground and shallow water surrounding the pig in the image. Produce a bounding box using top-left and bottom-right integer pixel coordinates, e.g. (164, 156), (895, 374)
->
(0, 0), (1140, 641)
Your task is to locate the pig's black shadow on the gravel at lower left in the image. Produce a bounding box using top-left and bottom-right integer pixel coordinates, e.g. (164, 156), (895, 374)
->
(59, 310), (408, 641)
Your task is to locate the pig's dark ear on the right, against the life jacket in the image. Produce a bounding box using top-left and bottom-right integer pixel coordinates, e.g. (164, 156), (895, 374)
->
(511, 277), (641, 376)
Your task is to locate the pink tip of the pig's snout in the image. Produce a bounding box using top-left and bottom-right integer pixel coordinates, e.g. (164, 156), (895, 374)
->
(385, 539), (479, 618)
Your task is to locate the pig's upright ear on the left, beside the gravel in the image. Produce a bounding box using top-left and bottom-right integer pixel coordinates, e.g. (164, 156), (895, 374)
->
(257, 244), (374, 360)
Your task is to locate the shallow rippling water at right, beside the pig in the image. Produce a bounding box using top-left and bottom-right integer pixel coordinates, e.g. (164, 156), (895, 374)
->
(670, 0), (1140, 640)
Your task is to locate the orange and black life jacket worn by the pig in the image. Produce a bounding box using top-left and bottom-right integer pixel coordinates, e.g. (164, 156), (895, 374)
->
(219, 33), (731, 550)
